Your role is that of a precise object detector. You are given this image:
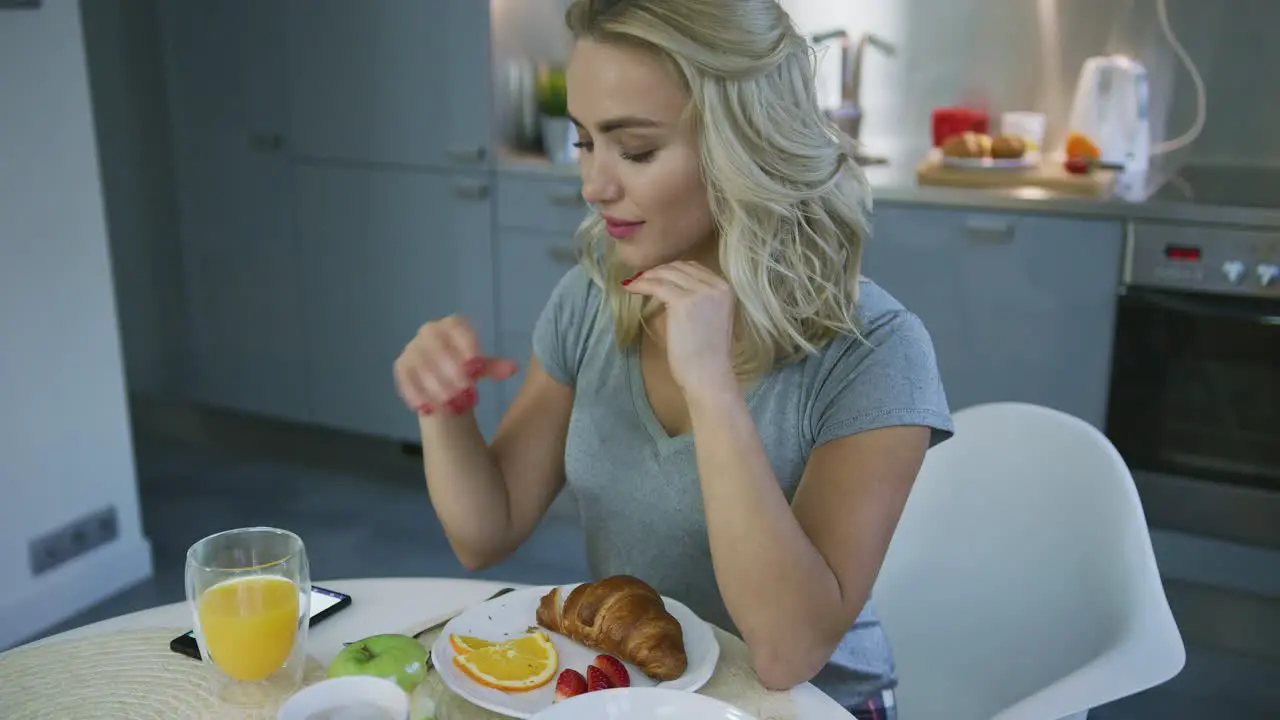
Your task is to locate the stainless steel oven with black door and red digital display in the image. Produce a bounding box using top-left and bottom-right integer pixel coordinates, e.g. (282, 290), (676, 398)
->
(1106, 223), (1280, 548)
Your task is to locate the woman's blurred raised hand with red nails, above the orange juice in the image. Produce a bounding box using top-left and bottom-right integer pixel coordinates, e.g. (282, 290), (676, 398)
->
(394, 315), (516, 415)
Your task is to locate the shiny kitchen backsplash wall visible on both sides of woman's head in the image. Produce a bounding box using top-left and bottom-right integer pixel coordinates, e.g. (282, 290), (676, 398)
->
(492, 0), (1280, 164)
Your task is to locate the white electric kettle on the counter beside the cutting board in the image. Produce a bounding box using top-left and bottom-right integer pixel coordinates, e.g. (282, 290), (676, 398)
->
(1068, 55), (1151, 173)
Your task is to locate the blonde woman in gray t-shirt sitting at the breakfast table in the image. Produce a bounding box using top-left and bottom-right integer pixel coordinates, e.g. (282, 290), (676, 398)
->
(396, 0), (952, 717)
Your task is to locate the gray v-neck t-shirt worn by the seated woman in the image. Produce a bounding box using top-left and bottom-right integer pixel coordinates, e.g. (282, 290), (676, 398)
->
(534, 268), (952, 706)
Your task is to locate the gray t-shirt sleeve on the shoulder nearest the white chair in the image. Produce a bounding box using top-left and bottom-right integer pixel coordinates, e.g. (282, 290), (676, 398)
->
(809, 310), (954, 447)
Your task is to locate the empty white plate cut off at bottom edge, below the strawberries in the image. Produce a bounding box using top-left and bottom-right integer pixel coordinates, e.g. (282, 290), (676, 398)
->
(534, 688), (755, 720)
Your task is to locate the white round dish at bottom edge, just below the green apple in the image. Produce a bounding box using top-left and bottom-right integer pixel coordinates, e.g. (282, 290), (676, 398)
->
(276, 675), (410, 720)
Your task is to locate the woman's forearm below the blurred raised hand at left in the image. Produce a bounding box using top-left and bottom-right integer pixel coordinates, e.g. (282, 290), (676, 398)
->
(419, 413), (512, 570)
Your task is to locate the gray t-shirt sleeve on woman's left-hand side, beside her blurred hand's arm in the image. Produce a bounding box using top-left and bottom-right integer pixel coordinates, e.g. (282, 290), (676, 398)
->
(534, 265), (595, 387)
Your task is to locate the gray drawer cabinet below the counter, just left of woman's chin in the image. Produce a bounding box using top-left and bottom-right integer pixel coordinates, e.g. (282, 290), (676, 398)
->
(495, 173), (586, 411)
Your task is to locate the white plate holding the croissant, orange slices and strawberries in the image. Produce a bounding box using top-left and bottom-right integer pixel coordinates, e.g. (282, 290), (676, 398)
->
(431, 584), (719, 717)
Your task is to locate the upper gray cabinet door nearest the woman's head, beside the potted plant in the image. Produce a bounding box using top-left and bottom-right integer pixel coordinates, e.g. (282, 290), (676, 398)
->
(287, 0), (493, 168)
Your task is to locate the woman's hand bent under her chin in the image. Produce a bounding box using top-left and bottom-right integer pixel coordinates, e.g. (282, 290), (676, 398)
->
(622, 261), (737, 396)
